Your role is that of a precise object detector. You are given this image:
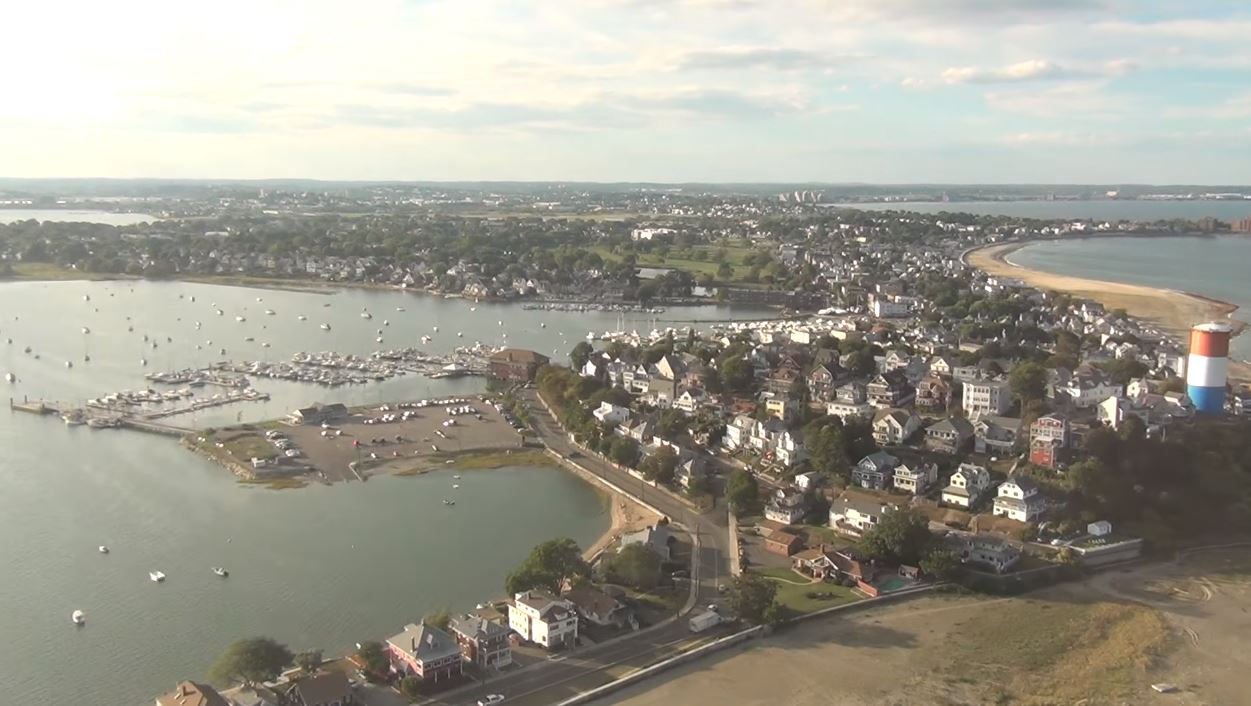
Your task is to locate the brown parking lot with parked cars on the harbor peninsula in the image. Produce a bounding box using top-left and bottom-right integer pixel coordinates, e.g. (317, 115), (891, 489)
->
(274, 398), (522, 481)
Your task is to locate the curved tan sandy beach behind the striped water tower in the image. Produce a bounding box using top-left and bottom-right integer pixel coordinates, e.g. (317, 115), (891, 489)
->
(963, 240), (1251, 383)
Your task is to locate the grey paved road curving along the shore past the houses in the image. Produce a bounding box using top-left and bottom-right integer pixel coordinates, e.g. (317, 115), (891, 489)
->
(435, 389), (729, 706)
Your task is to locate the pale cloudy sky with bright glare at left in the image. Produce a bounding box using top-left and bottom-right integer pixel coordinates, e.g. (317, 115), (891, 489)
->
(0, 0), (1251, 184)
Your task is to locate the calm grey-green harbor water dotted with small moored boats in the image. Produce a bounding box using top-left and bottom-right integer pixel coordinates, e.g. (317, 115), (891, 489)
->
(0, 282), (761, 706)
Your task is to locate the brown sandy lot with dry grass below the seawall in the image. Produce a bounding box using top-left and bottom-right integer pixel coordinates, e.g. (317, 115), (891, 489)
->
(603, 550), (1251, 706)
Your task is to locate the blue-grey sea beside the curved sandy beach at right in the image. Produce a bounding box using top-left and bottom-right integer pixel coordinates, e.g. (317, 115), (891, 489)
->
(1008, 235), (1251, 359)
